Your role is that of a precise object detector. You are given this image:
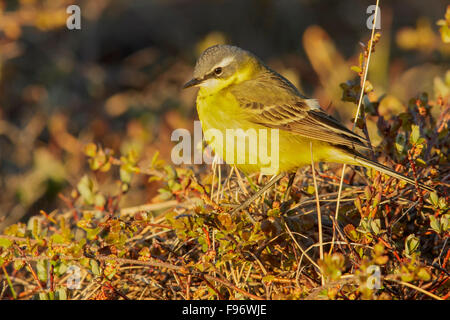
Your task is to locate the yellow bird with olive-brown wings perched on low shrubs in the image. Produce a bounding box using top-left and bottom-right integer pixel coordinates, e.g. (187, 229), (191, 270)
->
(183, 45), (433, 215)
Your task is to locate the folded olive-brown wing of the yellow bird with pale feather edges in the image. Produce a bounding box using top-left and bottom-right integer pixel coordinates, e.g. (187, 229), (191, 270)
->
(231, 71), (369, 149)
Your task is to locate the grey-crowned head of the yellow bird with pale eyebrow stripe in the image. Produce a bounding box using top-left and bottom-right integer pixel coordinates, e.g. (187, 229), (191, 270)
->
(183, 45), (261, 93)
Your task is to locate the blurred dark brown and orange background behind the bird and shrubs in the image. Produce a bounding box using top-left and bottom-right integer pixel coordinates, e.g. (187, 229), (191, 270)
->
(0, 0), (450, 229)
